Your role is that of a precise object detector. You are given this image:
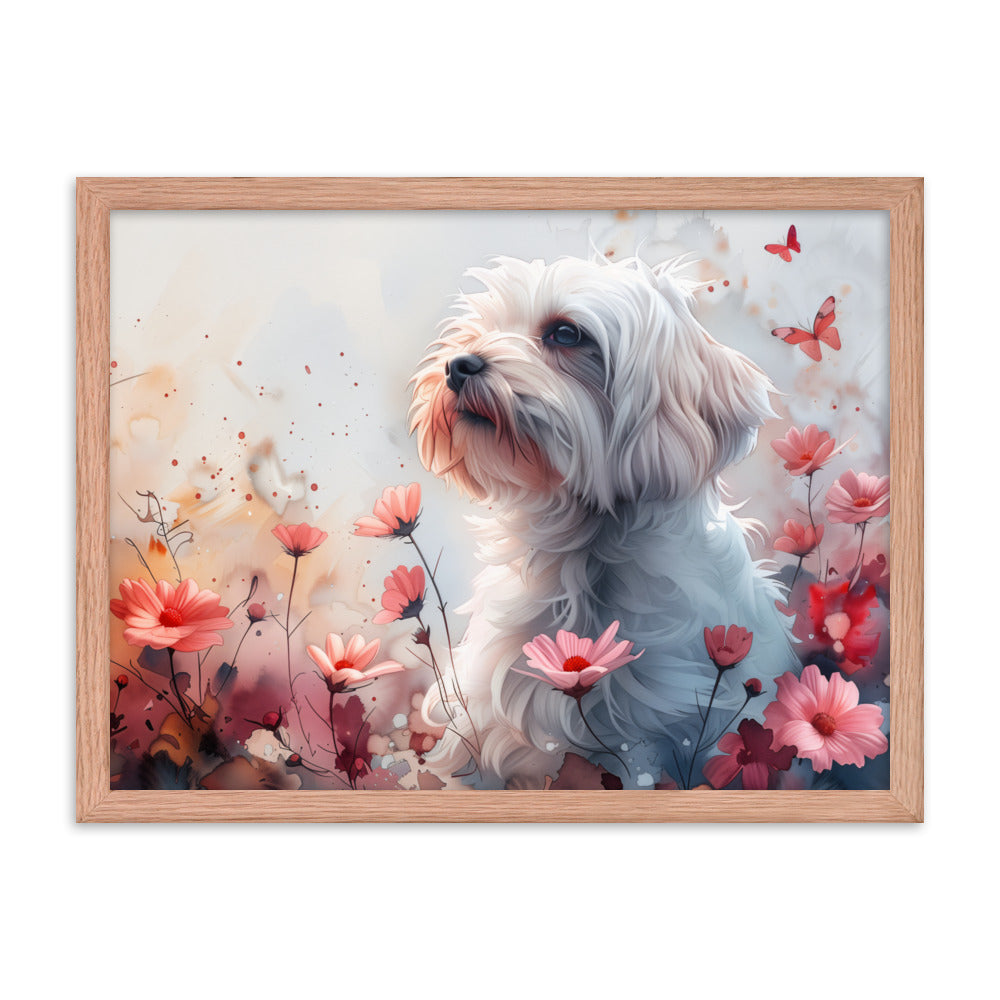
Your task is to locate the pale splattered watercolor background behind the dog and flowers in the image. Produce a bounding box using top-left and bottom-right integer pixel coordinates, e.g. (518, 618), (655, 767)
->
(109, 211), (889, 787)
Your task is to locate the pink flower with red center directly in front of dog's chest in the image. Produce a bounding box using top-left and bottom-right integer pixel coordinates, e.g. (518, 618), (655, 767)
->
(513, 622), (642, 698)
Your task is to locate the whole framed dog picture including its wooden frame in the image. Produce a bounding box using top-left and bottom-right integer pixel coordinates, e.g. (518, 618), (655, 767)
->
(77, 178), (923, 822)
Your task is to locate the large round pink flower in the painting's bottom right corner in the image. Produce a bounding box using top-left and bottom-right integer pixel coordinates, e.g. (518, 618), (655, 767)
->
(764, 663), (889, 771)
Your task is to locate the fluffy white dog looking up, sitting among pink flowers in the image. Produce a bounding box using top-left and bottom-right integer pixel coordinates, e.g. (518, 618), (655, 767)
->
(410, 258), (797, 787)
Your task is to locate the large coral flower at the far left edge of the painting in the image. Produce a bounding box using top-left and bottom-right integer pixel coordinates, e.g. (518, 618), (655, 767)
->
(111, 580), (233, 653)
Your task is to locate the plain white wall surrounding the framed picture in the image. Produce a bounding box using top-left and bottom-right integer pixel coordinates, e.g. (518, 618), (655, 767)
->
(0, 0), (984, 998)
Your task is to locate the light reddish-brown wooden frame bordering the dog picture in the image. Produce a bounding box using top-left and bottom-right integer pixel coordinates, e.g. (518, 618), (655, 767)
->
(77, 178), (923, 823)
